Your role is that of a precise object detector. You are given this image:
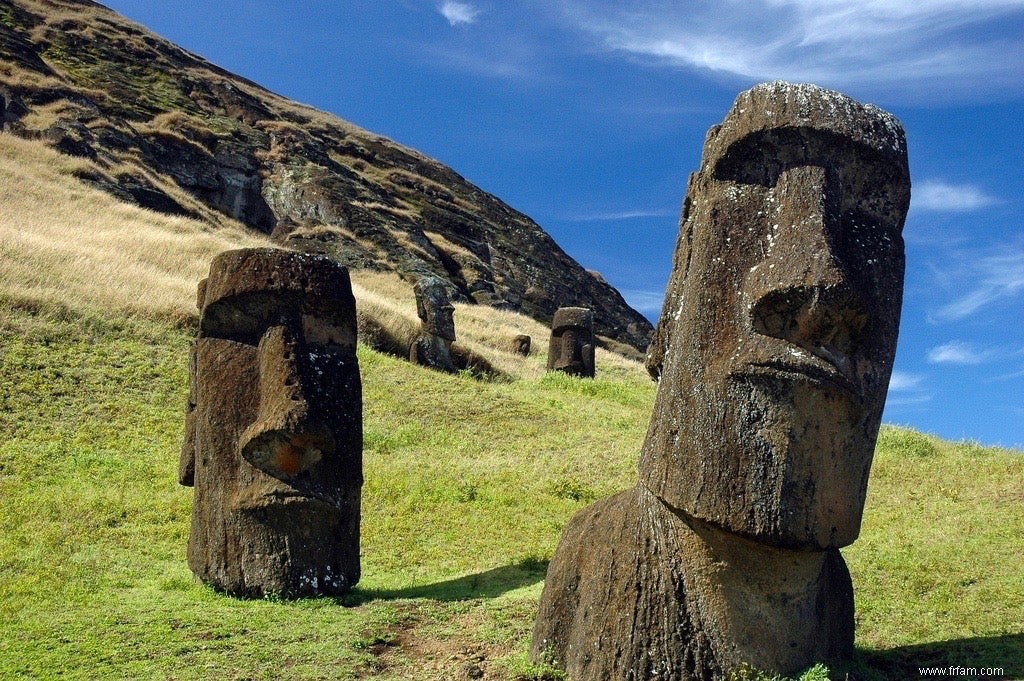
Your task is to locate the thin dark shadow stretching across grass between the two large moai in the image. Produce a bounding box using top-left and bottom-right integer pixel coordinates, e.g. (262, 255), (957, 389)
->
(343, 559), (548, 605)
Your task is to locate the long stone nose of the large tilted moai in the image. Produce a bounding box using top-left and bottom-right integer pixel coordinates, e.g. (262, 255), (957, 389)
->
(744, 166), (868, 360)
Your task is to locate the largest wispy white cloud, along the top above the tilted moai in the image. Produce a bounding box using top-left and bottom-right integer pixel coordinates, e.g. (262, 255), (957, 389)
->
(562, 0), (1024, 95)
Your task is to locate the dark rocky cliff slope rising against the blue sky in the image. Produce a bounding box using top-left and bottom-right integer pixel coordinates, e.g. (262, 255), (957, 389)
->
(0, 0), (651, 350)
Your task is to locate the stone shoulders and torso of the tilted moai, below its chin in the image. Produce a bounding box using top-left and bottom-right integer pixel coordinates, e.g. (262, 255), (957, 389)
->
(531, 485), (853, 681)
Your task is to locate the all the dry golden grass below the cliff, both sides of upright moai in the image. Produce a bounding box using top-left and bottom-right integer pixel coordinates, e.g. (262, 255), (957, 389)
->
(0, 134), (646, 381)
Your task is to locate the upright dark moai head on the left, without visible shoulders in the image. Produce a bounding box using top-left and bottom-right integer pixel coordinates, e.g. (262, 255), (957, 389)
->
(179, 248), (362, 597)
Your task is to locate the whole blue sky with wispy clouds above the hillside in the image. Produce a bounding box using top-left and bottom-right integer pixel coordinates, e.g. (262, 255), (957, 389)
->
(97, 0), (1024, 448)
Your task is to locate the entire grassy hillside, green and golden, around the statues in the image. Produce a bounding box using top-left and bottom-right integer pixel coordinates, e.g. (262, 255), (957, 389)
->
(0, 135), (1024, 681)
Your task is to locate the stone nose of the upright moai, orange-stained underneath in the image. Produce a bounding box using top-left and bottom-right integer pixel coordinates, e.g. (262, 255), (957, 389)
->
(239, 326), (335, 479)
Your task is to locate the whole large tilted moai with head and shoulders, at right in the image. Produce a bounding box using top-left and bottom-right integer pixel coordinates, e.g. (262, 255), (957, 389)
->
(531, 82), (910, 681)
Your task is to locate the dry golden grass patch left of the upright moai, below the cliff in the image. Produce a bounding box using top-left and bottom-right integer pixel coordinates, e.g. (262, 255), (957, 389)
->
(0, 134), (269, 320)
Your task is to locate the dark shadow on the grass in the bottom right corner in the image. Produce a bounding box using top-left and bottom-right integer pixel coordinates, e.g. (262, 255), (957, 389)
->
(858, 634), (1024, 679)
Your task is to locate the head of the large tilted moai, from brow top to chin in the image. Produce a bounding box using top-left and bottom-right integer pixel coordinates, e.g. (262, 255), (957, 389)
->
(640, 82), (910, 549)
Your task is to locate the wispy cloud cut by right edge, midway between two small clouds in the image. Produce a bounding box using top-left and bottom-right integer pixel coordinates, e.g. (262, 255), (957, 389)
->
(933, 246), (1024, 322)
